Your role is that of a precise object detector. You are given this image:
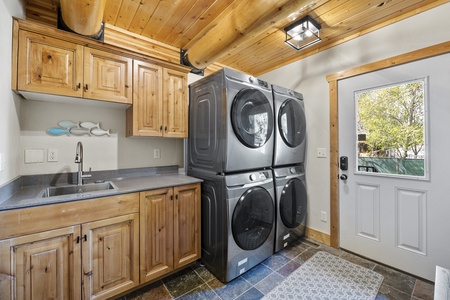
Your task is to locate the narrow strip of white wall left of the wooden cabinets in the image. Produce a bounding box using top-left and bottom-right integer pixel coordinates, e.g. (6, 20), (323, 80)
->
(0, 0), (24, 185)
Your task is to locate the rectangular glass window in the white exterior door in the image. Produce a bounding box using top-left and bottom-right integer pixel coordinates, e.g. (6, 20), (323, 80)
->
(355, 79), (428, 178)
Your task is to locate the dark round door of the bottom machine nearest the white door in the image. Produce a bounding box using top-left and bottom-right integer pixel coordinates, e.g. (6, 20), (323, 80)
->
(280, 178), (306, 228)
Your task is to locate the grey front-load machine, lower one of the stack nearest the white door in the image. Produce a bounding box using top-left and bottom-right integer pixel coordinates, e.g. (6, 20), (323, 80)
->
(273, 165), (307, 252)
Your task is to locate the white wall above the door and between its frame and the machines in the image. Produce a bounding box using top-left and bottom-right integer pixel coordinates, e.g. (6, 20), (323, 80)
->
(259, 3), (450, 237)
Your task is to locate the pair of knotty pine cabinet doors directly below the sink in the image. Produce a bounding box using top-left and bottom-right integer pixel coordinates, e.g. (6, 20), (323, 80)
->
(0, 213), (139, 299)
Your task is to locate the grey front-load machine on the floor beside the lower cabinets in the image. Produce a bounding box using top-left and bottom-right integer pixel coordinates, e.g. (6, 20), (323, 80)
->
(188, 170), (275, 283)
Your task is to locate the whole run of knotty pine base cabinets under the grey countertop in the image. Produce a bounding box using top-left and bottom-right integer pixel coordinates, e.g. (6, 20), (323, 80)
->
(0, 184), (200, 300)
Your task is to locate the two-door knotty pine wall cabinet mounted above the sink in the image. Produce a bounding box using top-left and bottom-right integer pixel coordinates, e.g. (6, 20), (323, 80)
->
(17, 30), (133, 104)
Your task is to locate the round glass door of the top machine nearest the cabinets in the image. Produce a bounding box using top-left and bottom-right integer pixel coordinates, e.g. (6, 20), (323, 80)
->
(231, 89), (273, 148)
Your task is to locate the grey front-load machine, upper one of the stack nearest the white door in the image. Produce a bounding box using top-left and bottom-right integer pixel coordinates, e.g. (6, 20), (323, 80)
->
(272, 84), (306, 167)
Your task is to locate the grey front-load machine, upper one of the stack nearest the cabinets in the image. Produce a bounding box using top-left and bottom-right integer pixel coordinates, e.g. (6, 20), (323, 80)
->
(188, 69), (274, 174)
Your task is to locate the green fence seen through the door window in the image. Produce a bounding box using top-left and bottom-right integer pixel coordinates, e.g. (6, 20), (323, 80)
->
(358, 157), (425, 176)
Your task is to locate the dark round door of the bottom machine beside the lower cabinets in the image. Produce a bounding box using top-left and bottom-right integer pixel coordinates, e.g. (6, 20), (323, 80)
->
(231, 187), (275, 250)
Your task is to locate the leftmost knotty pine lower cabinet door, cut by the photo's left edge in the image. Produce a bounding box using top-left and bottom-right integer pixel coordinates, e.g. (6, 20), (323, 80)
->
(0, 226), (81, 300)
